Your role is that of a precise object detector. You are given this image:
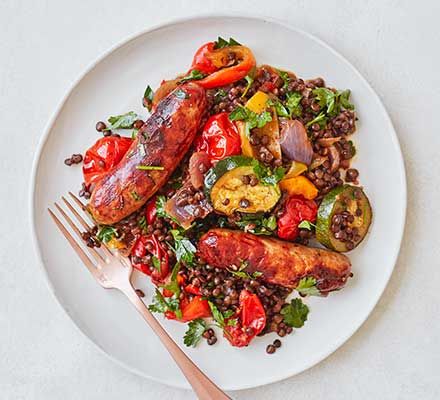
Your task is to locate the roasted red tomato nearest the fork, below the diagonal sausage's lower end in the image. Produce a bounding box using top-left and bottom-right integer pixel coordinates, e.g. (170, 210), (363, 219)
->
(131, 235), (170, 283)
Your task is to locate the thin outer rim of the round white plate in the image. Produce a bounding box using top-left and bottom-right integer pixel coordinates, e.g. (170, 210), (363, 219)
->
(28, 12), (408, 391)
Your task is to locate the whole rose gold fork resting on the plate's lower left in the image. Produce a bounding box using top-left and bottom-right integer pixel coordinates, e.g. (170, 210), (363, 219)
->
(48, 192), (230, 400)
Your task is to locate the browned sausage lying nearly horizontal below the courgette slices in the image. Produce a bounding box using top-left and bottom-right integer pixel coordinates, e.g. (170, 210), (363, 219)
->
(198, 229), (351, 295)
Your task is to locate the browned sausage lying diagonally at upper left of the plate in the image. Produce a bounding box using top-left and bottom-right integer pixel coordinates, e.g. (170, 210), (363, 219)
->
(88, 83), (207, 225)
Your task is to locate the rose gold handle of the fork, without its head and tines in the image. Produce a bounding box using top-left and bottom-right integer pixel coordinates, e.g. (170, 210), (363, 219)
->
(123, 287), (231, 400)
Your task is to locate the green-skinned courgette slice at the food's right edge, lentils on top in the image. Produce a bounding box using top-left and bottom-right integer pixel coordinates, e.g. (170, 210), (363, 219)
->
(316, 185), (373, 253)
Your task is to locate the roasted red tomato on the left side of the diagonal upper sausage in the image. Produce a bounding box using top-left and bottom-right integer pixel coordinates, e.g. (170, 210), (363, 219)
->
(83, 136), (133, 185)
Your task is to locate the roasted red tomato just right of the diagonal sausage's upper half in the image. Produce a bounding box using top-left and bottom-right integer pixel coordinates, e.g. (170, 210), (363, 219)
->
(196, 113), (241, 161)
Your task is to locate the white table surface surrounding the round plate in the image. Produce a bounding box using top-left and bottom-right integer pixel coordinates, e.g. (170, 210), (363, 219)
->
(0, 0), (440, 400)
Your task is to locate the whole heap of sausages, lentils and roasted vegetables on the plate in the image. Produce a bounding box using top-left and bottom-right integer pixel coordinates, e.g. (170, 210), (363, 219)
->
(65, 38), (372, 354)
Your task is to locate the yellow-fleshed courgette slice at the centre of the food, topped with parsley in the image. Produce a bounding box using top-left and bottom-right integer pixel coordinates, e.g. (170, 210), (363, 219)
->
(205, 156), (281, 215)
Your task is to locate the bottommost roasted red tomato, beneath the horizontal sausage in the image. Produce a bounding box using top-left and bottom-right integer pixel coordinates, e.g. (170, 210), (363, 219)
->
(224, 290), (266, 347)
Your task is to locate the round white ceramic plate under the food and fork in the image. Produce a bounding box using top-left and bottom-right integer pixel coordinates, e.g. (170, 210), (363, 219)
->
(31, 16), (406, 390)
